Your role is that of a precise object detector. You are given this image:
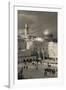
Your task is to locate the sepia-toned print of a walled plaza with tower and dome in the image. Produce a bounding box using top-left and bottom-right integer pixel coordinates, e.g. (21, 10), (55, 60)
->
(17, 10), (58, 80)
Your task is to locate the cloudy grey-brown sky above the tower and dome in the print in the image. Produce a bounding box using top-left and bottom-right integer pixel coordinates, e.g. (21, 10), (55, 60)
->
(18, 10), (57, 39)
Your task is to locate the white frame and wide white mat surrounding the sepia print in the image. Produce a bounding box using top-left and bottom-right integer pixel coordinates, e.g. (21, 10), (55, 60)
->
(9, 3), (64, 88)
